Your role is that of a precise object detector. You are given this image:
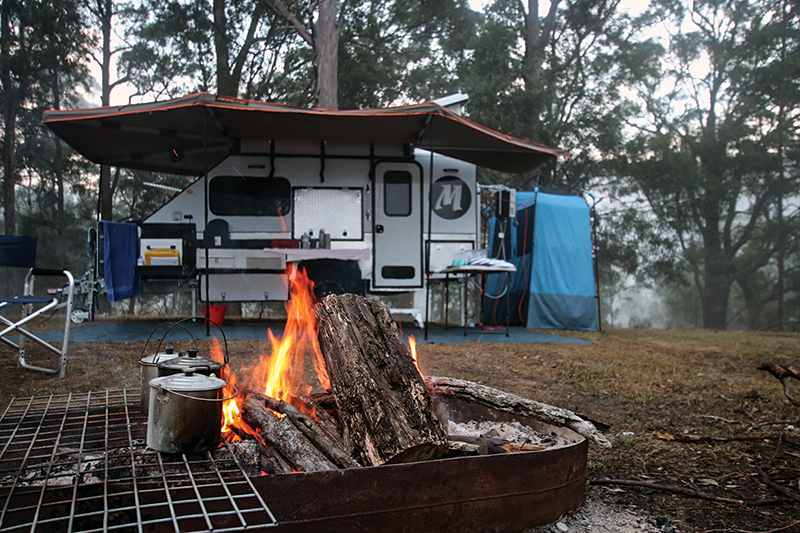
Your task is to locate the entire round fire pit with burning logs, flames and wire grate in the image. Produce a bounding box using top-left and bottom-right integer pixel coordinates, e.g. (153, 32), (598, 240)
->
(0, 273), (605, 533)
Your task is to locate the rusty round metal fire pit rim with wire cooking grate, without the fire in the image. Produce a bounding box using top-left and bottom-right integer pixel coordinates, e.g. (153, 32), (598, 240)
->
(0, 390), (588, 533)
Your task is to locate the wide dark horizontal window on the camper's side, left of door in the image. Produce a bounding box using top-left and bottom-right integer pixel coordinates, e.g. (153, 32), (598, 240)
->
(208, 176), (292, 217)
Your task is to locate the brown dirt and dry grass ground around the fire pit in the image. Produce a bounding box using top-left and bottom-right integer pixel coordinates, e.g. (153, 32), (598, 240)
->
(0, 325), (800, 533)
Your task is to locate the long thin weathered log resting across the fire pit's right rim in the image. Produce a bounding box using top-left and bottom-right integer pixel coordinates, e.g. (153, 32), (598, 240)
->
(425, 377), (611, 448)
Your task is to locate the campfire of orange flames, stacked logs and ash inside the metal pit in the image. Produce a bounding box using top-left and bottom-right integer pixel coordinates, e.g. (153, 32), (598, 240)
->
(206, 270), (607, 474)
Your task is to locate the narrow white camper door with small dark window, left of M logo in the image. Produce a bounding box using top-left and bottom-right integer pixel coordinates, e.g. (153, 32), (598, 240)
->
(372, 162), (423, 289)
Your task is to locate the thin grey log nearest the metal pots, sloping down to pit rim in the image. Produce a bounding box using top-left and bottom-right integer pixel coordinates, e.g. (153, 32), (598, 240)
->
(241, 395), (337, 472)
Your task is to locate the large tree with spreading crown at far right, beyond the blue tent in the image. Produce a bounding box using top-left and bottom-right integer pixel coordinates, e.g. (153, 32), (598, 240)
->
(619, 0), (800, 329)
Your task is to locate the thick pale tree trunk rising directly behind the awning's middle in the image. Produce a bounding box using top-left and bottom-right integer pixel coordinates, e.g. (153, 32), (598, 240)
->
(314, 0), (339, 109)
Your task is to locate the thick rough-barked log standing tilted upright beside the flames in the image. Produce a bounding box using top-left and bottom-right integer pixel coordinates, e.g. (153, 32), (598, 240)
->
(316, 294), (447, 466)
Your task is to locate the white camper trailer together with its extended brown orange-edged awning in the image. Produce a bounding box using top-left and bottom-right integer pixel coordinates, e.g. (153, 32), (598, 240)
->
(45, 94), (566, 322)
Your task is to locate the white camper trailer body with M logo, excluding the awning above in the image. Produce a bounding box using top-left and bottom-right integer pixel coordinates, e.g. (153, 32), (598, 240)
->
(138, 142), (479, 312)
